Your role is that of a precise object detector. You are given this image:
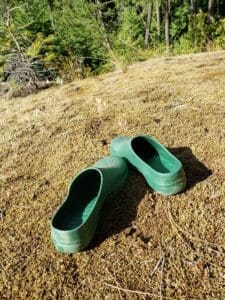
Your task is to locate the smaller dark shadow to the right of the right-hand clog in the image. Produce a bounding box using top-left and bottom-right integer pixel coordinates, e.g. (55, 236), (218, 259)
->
(168, 147), (212, 190)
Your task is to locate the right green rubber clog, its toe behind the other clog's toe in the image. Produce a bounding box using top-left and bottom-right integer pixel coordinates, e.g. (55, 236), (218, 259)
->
(110, 136), (186, 195)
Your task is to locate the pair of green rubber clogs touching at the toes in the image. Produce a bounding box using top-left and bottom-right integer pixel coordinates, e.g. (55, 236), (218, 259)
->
(51, 136), (186, 253)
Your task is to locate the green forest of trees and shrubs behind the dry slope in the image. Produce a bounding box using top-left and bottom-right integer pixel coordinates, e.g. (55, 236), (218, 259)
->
(0, 0), (225, 93)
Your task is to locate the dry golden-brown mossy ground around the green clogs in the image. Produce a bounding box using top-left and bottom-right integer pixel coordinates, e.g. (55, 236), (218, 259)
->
(0, 52), (225, 299)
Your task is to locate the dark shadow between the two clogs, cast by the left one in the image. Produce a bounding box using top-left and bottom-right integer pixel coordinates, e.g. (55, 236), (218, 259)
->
(86, 168), (149, 250)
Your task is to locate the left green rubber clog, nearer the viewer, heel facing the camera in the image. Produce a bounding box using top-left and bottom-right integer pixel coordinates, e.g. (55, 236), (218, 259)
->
(51, 156), (128, 253)
